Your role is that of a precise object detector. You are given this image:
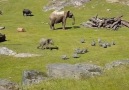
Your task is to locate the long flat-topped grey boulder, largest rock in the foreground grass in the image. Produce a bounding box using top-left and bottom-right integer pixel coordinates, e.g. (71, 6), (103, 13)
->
(47, 64), (103, 79)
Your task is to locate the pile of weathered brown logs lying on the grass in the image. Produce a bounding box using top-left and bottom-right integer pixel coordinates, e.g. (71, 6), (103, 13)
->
(81, 15), (129, 30)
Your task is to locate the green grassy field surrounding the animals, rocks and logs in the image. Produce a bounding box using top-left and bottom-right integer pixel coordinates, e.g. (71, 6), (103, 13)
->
(0, 0), (129, 90)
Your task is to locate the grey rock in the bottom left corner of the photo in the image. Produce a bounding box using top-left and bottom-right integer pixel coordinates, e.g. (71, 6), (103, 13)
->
(0, 79), (19, 90)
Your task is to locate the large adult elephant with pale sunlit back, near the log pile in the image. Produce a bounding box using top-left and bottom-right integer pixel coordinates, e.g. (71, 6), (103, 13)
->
(49, 10), (75, 30)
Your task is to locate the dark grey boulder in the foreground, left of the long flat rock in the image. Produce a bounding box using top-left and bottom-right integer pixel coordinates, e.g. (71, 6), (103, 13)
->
(22, 70), (47, 85)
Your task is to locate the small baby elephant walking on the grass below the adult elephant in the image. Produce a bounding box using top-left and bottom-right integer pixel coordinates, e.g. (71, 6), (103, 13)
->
(37, 38), (54, 49)
